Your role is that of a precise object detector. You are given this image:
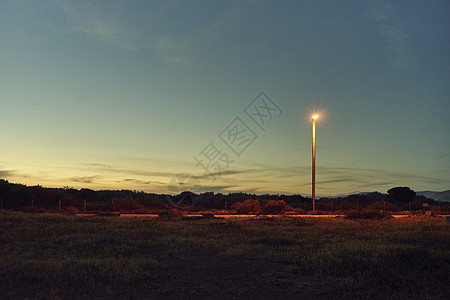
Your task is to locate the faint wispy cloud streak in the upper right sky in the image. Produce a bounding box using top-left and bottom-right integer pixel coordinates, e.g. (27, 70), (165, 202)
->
(366, 0), (412, 69)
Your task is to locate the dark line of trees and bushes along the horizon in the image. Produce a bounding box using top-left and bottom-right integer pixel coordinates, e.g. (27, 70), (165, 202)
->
(0, 179), (448, 213)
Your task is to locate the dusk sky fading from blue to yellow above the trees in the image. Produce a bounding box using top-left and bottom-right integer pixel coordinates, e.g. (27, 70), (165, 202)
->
(0, 0), (450, 196)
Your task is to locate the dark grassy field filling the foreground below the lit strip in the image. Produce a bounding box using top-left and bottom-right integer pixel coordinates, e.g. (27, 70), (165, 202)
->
(0, 212), (450, 299)
